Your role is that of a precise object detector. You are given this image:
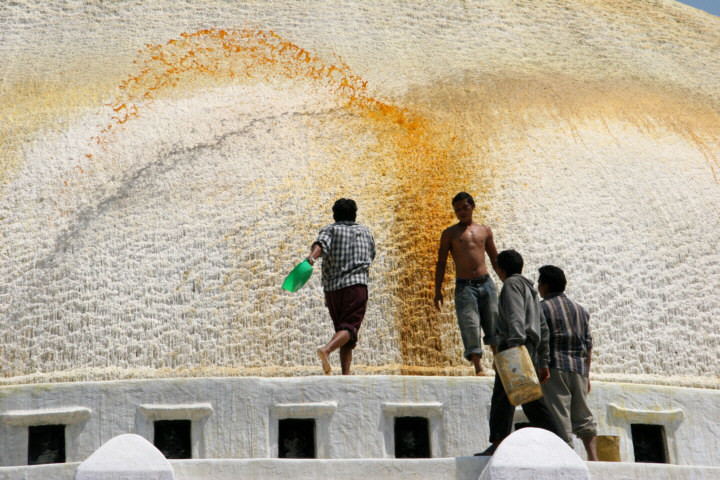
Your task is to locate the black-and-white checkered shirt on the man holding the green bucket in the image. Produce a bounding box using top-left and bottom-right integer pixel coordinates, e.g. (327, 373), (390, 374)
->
(313, 221), (375, 292)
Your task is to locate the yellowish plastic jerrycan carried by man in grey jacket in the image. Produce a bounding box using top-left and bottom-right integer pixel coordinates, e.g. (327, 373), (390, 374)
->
(495, 345), (542, 406)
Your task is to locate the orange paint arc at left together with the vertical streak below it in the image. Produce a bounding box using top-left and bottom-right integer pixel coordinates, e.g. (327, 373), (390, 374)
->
(90, 28), (477, 374)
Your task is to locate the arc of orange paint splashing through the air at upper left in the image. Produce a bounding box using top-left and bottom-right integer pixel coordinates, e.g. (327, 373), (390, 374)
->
(97, 28), (406, 143)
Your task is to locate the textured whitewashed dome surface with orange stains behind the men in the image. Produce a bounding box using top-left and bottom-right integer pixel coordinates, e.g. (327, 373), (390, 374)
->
(0, 0), (720, 387)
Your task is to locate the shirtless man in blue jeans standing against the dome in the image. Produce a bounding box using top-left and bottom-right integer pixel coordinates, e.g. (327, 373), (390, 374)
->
(435, 192), (498, 375)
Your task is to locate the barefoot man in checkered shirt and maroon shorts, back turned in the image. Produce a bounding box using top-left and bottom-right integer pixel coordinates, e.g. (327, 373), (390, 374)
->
(308, 198), (375, 375)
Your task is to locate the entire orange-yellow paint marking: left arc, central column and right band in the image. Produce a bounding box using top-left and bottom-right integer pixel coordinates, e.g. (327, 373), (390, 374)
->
(43, 29), (720, 375)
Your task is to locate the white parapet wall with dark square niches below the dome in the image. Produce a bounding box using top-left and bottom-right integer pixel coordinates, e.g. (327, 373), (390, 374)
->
(0, 376), (720, 468)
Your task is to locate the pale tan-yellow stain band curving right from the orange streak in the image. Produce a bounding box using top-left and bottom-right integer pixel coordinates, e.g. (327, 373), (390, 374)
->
(406, 72), (720, 179)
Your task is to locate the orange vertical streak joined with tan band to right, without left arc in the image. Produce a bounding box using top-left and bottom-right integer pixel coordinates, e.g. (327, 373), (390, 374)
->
(380, 72), (720, 374)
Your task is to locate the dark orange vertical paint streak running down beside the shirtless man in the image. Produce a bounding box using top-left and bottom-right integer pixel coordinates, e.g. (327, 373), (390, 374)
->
(352, 103), (486, 374)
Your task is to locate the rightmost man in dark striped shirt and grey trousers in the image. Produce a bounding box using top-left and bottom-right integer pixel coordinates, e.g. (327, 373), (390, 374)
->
(538, 265), (597, 460)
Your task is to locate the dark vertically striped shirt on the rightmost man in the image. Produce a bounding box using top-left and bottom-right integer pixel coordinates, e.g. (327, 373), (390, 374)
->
(540, 293), (592, 377)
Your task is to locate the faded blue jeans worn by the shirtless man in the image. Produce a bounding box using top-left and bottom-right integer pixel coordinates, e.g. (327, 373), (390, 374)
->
(455, 275), (498, 360)
